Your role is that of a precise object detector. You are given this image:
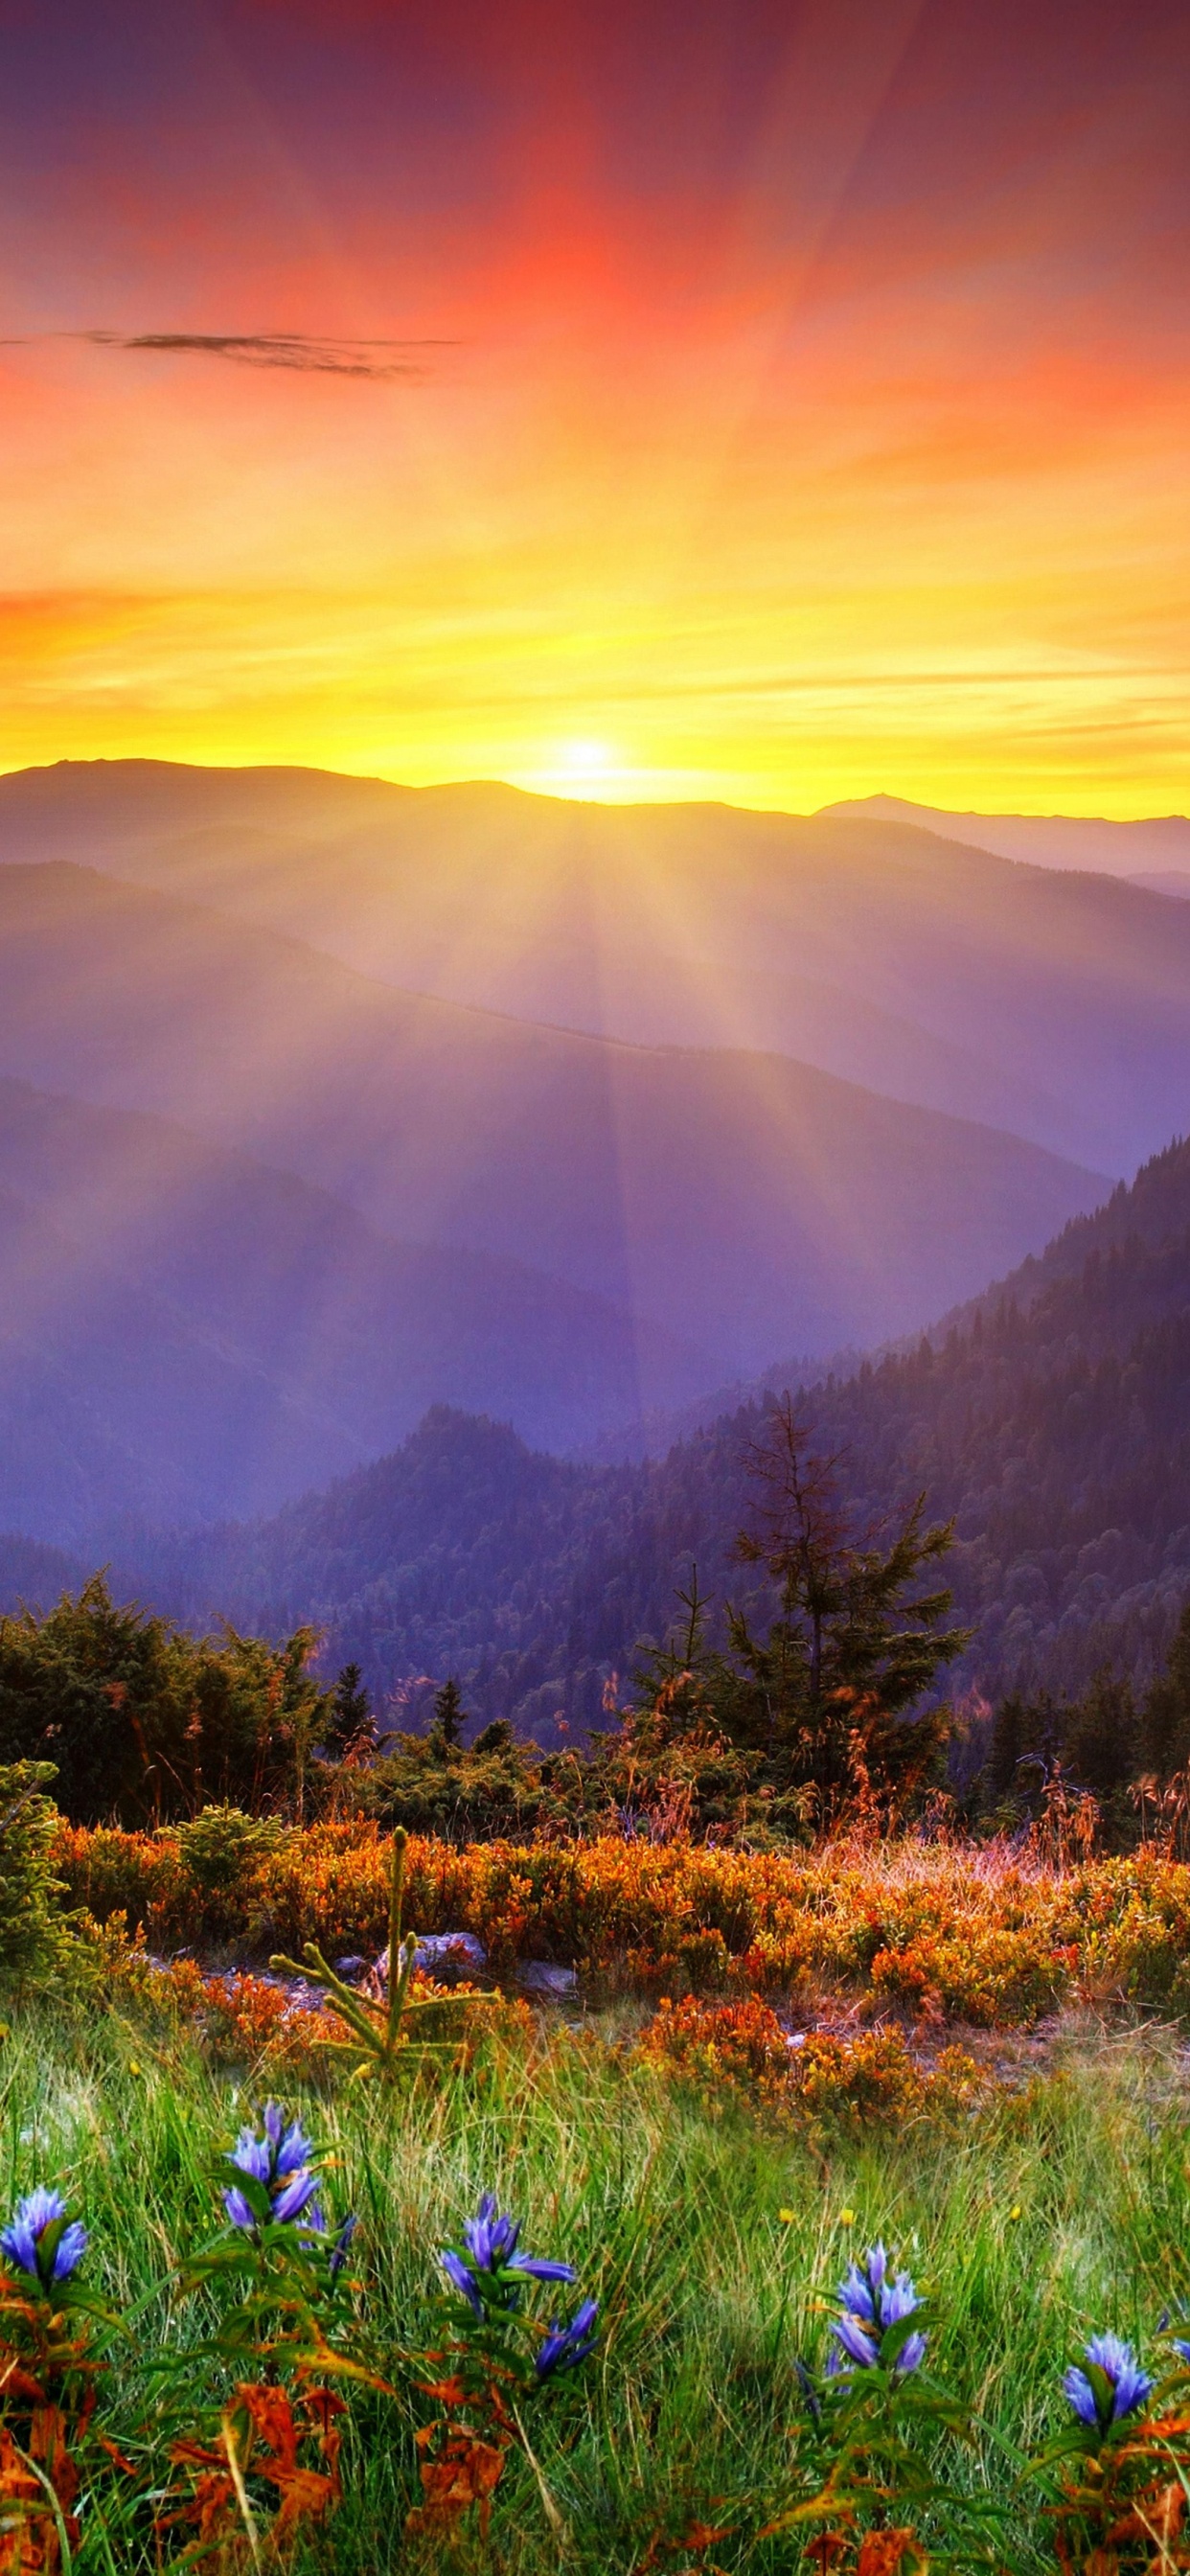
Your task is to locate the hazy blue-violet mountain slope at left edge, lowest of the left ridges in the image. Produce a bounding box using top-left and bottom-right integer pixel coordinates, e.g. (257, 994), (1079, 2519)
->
(0, 1079), (716, 1546)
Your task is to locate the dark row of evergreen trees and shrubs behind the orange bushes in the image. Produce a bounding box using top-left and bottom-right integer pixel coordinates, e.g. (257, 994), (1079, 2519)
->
(0, 1399), (1190, 1845)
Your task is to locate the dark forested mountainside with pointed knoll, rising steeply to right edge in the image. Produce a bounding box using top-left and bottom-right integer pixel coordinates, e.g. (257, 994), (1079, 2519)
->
(111, 1143), (1190, 1741)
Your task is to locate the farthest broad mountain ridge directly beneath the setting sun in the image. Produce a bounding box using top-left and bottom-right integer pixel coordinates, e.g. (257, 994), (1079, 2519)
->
(0, 760), (1190, 1163)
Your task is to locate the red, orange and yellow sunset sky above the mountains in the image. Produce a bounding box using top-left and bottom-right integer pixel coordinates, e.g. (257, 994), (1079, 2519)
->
(0, 0), (1190, 816)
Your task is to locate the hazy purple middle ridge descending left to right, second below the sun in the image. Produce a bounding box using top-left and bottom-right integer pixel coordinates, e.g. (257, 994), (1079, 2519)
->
(0, 862), (1102, 1438)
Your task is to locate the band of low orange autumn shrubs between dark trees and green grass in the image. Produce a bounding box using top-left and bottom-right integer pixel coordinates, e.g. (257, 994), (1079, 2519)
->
(52, 1819), (1190, 2027)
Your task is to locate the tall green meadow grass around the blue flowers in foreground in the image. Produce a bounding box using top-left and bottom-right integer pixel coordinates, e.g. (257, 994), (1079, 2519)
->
(0, 2012), (1190, 2576)
